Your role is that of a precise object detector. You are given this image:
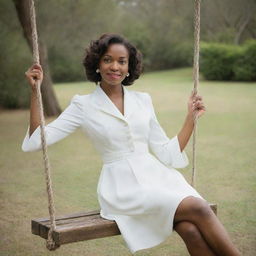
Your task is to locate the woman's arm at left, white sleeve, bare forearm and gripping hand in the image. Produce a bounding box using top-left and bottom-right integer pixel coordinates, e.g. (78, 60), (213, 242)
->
(22, 65), (85, 152)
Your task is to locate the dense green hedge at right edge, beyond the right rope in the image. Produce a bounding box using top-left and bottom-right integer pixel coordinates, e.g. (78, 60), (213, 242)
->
(200, 40), (256, 81)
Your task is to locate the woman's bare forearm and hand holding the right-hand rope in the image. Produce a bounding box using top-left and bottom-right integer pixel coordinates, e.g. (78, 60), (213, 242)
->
(178, 93), (205, 152)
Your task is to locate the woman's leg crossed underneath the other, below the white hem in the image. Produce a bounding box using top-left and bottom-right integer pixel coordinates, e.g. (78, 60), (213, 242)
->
(174, 221), (216, 256)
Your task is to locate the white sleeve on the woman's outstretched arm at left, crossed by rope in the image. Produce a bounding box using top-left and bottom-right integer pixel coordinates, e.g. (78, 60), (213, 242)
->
(22, 95), (83, 152)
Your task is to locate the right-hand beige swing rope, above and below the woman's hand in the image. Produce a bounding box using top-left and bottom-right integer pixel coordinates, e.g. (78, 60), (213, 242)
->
(191, 0), (201, 187)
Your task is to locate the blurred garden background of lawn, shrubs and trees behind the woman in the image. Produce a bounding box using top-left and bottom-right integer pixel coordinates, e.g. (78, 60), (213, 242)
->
(0, 0), (256, 256)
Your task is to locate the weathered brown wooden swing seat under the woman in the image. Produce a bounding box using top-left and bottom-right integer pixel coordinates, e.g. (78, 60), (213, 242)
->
(31, 204), (217, 246)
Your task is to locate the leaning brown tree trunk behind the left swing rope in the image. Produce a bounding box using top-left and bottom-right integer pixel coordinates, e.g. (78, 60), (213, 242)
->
(13, 0), (61, 116)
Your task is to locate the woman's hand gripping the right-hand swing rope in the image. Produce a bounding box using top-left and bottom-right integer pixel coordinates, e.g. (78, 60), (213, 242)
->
(188, 92), (205, 118)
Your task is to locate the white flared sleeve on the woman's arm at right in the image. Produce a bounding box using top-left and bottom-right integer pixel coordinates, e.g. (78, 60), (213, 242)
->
(146, 94), (188, 168)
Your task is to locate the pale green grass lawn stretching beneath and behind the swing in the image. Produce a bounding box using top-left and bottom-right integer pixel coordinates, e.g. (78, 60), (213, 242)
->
(0, 69), (256, 256)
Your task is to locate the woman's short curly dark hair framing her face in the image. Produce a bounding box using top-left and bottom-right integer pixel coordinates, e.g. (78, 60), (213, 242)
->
(83, 34), (142, 85)
